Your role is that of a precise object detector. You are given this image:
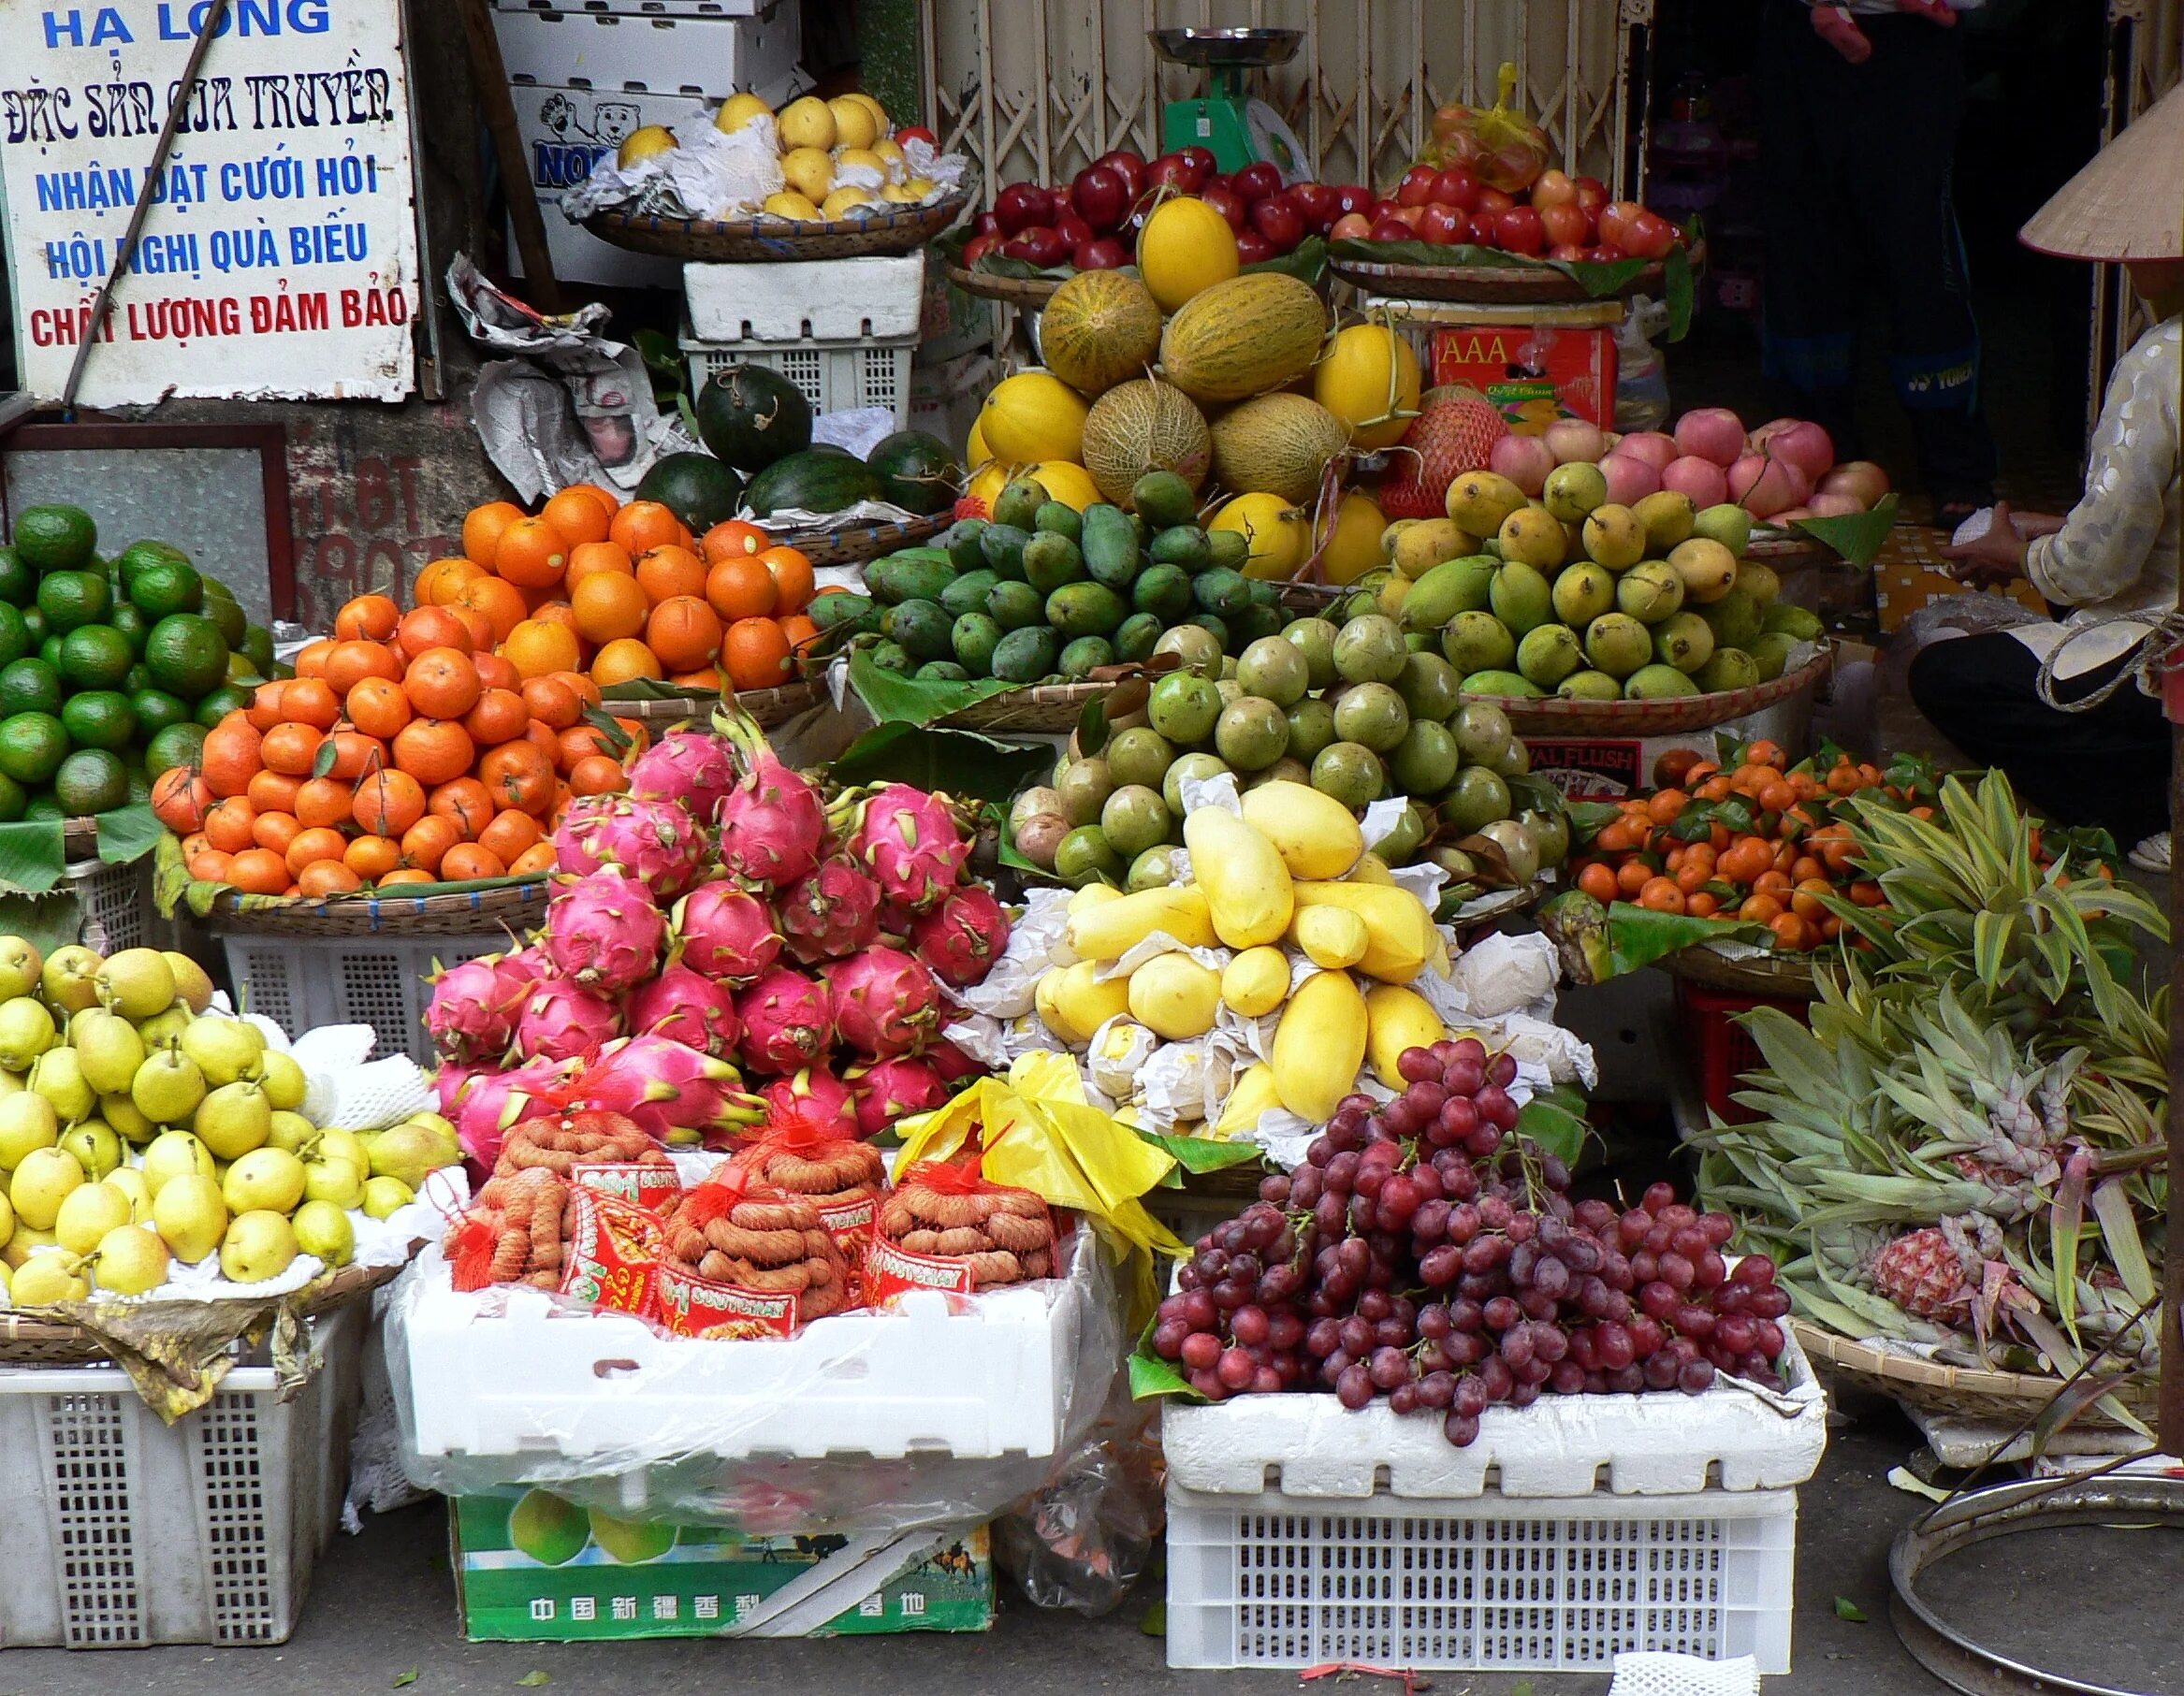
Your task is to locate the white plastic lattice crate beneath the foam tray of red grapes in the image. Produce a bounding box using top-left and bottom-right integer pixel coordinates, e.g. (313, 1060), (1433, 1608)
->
(1166, 1482), (1798, 1674)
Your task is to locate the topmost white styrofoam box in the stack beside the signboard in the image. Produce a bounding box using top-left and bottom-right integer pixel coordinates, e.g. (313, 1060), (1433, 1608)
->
(493, 0), (804, 105)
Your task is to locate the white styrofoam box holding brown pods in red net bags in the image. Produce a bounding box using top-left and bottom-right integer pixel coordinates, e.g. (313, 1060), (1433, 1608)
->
(395, 1249), (1084, 1460)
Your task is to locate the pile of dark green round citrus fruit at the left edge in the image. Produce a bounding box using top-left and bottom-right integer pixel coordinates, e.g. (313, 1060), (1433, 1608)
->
(0, 504), (273, 823)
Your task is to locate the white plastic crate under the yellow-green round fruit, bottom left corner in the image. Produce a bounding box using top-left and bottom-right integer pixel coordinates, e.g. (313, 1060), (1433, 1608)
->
(0, 1301), (369, 1648)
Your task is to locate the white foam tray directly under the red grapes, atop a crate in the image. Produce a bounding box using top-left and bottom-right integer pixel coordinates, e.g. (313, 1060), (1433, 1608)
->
(1159, 1338), (1828, 1500)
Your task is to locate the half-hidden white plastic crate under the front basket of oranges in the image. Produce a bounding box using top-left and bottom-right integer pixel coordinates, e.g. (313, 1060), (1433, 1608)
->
(218, 930), (509, 1065)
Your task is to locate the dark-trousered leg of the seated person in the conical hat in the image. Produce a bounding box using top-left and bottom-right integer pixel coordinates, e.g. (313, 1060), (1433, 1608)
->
(1911, 631), (2169, 849)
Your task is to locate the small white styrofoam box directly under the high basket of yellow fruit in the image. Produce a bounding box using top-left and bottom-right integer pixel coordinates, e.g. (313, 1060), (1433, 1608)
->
(684, 254), (926, 342)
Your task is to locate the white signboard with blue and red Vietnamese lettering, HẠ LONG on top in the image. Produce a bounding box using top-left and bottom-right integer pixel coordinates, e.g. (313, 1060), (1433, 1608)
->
(0, 0), (419, 406)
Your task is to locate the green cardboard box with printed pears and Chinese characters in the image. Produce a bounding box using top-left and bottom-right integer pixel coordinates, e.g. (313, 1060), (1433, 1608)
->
(450, 1491), (994, 1644)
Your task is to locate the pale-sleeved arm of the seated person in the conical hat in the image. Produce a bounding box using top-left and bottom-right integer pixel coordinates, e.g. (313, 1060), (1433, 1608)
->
(2025, 332), (2177, 607)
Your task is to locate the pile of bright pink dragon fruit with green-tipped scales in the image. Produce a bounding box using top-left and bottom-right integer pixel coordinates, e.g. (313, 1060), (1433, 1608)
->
(426, 716), (1009, 1166)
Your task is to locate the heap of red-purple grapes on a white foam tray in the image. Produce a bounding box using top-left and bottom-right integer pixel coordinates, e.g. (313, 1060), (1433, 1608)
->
(1153, 1036), (1789, 1447)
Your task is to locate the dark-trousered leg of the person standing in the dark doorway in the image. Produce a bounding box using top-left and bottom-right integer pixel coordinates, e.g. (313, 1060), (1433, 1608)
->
(1843, 18), (1994, 515)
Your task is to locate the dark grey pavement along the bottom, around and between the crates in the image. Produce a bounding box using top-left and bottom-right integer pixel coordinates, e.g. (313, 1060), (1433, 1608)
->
(0, 1379), (2184, 1696)
